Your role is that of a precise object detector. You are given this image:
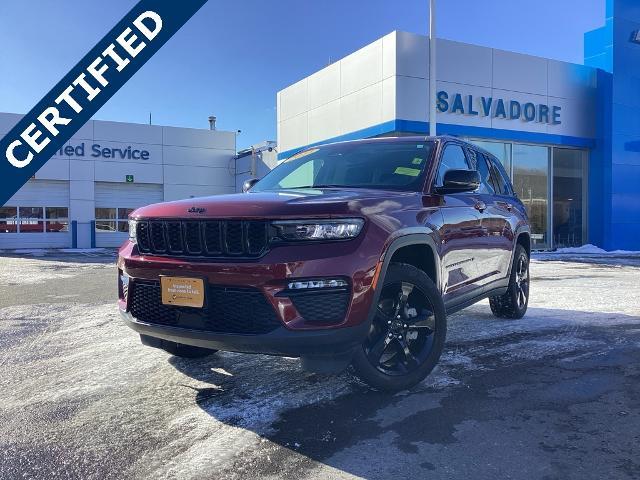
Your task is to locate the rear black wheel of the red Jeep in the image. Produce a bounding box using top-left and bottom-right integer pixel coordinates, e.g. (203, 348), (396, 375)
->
(489, 245), (529, 319)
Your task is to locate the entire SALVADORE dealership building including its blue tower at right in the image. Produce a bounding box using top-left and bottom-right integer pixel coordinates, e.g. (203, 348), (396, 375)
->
(277, 0), (640, 250)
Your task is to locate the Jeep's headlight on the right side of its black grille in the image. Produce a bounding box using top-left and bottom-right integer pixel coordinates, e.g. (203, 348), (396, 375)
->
(273, 218), (364, 241)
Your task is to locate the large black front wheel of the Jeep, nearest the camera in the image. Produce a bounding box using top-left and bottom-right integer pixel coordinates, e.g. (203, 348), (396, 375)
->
(352, 263), (447, 391)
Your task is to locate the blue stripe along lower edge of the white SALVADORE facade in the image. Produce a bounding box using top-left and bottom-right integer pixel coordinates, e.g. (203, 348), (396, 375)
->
(278, 119), (596, 160)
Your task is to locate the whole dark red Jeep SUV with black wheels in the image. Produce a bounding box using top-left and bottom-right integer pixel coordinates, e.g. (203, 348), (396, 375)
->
(118, 137), (530, 390)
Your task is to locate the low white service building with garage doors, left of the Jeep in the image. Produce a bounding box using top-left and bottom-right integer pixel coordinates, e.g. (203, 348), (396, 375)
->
(0, 113), (244, 249)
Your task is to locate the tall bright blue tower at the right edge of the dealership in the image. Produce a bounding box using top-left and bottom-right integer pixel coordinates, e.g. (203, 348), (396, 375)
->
(585, 0), (640, 250)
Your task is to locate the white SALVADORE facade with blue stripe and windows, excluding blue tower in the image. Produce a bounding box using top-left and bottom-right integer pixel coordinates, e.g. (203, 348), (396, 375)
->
(277, 31), (599, 249)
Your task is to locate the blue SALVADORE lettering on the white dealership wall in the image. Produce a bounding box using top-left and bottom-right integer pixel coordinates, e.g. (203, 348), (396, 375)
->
(437, 90), (562, 125)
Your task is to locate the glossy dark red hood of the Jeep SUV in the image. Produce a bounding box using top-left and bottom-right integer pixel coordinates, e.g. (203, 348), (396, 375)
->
(131, 188), (420, 219)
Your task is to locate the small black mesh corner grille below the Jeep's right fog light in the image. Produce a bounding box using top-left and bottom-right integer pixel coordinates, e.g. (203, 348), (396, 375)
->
(289, 290), (351, 324)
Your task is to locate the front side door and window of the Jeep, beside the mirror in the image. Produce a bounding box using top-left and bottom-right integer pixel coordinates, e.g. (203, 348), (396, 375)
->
(435, 143), (484, 305)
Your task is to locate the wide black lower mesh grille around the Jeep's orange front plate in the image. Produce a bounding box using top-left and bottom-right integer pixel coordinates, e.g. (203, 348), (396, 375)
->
(129, 281), (282, 335)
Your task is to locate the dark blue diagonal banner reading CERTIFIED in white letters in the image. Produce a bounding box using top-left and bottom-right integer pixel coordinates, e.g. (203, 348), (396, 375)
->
(0, 0), (207, 206)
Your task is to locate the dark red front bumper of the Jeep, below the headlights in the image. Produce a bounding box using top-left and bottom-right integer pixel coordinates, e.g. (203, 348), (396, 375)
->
(118, 239), (379, 334)
